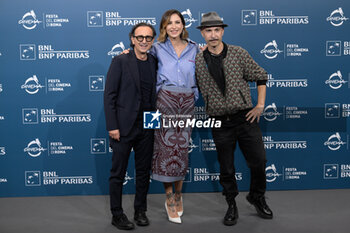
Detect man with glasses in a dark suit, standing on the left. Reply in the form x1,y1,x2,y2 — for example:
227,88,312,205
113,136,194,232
104,23,157,230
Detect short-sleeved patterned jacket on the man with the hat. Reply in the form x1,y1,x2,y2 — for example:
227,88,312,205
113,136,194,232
196,45,267,116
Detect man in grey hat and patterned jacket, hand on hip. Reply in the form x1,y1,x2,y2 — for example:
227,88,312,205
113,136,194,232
196,12,273,226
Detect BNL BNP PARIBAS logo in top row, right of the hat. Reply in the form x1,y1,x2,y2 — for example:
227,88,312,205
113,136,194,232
241,10,309,26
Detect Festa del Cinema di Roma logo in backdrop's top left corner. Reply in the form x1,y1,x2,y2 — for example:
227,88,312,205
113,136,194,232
18,10,69,30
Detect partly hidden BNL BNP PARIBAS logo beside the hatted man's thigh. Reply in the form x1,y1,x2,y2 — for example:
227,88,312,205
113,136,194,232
263,136,307,150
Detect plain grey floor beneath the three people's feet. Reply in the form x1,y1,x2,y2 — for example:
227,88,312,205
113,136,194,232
0,189,350,233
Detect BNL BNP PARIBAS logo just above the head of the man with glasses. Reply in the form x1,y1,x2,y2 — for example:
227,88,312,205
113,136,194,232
87,11,157,27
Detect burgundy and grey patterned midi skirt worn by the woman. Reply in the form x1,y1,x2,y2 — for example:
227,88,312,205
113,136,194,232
152,86,194,182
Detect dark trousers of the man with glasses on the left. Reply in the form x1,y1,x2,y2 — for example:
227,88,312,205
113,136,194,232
109,120,154,216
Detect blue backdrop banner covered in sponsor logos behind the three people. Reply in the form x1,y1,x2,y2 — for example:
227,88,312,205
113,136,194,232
0,0,350,197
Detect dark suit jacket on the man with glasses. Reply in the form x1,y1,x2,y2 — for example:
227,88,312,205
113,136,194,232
104,50,157,136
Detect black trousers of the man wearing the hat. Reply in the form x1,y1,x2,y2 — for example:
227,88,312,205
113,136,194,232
212,114,266,199
